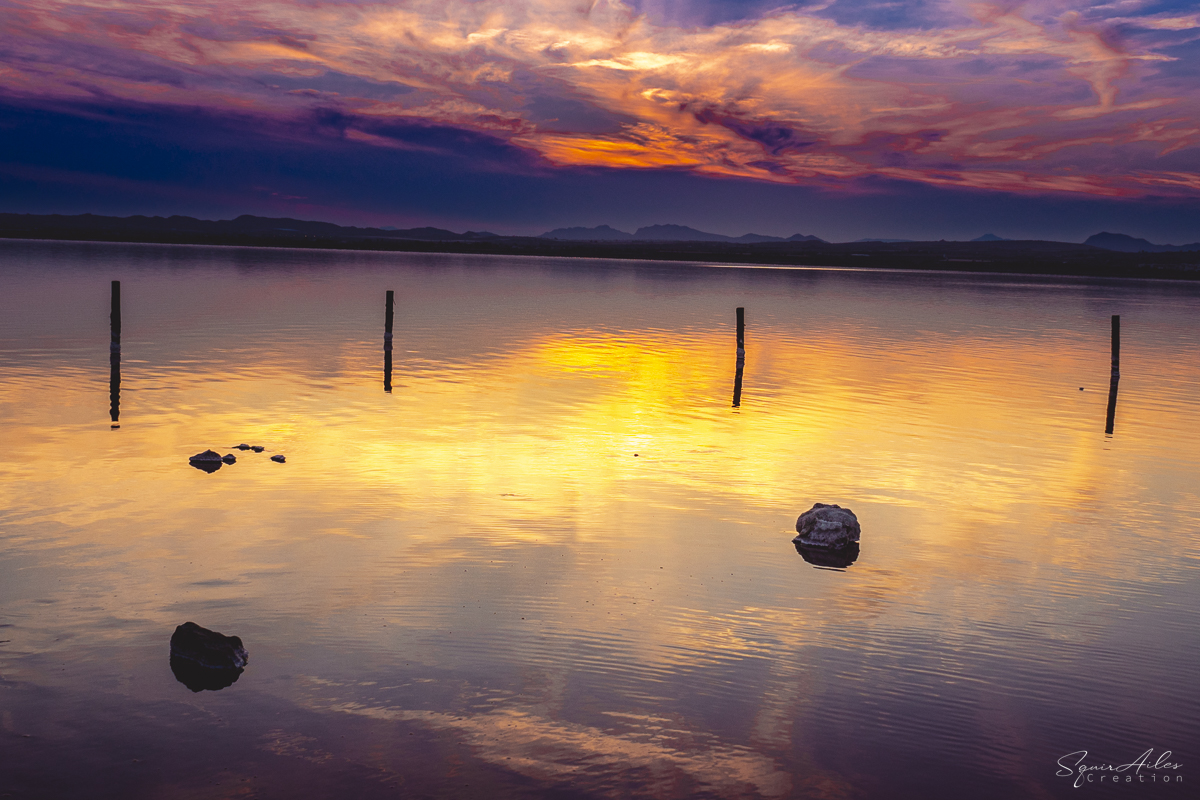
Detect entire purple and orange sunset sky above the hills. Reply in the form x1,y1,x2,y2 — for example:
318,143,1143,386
0,0,1200,243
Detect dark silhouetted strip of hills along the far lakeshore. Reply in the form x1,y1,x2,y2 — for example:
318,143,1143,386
0,213,1200,279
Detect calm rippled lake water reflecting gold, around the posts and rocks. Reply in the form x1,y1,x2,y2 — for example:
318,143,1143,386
0,241,1200,800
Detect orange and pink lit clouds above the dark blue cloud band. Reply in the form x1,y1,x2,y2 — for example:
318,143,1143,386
0,0,1200,197
